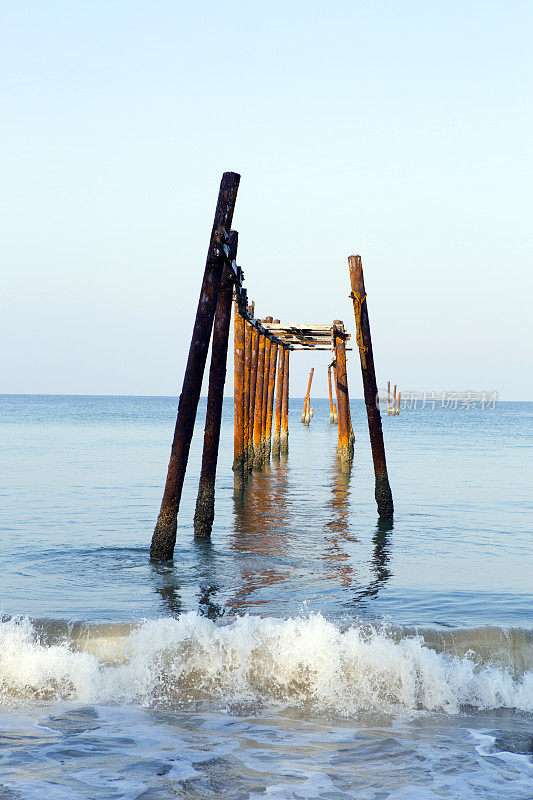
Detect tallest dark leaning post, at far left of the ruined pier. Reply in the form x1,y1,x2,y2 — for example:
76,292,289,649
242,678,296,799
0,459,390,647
150,172,240,560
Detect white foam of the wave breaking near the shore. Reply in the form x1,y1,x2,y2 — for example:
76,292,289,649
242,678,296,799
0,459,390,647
0,613,533,716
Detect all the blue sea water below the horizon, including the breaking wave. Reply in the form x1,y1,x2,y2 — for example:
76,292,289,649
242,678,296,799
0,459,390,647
0,395,533,800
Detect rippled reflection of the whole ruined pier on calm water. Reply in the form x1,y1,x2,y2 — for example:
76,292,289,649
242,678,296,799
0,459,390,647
151,444,393,619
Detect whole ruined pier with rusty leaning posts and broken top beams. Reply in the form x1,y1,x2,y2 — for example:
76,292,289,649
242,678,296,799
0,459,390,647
150,172,390,560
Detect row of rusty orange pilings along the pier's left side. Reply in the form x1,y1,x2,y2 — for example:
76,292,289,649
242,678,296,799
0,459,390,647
233,302,290,489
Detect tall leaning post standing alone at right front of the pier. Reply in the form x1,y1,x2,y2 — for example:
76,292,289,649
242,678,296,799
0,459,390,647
348,256,394,517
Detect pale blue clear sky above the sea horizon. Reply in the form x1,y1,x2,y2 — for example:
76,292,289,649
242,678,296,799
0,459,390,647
0,0,533,400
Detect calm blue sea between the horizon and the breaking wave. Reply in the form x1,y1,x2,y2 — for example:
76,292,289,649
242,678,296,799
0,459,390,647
0,397,531,627
